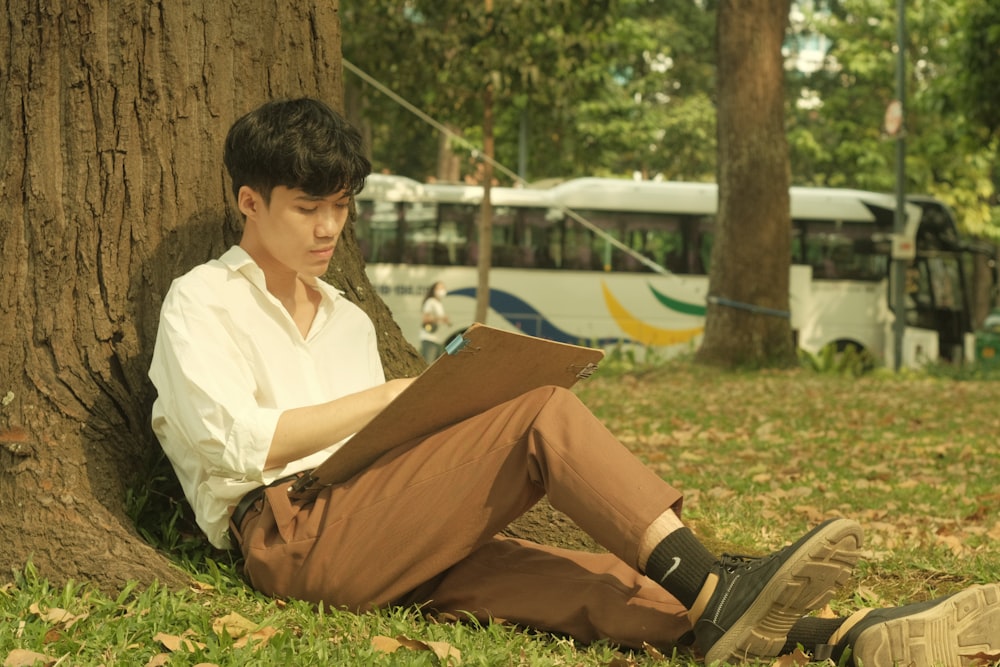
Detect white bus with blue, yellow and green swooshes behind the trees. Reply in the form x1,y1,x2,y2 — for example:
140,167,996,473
357,175,988,365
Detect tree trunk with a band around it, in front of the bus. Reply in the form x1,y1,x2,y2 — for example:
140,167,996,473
697,0,796,367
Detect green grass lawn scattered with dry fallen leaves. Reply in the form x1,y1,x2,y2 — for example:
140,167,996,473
0,362,1000,666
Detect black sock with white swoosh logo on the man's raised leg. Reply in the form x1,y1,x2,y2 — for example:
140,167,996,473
645,528,718,609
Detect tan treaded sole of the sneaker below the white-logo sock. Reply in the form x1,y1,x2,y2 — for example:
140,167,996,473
705,519,864,665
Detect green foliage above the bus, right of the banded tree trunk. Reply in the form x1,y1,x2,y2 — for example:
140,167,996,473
789,0,1000,238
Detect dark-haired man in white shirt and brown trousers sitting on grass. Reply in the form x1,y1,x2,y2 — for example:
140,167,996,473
150,99,1000,664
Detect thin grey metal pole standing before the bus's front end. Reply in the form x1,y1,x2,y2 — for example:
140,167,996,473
891,0,908,371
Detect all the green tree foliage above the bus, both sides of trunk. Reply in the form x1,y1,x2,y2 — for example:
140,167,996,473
342,0,1000,238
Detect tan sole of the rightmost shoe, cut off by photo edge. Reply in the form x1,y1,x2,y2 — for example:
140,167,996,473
851,584,1000,667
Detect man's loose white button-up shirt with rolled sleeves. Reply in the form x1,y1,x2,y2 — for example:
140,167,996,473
149,246,385,548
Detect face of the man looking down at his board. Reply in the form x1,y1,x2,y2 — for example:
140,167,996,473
240,185,351,277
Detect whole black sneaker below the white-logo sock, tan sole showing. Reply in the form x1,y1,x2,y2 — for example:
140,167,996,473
693,519,861,665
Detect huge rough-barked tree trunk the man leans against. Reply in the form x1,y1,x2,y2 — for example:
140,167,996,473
0,0,420,589
